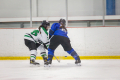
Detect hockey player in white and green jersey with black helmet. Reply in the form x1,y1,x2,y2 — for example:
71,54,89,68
24,20,50,65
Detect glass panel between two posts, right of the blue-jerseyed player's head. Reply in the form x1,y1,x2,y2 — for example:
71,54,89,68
68,0,103,27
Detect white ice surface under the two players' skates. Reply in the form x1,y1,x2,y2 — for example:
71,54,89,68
0,59,120,80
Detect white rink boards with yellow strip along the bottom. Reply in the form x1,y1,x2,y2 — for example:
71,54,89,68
0,27,120,60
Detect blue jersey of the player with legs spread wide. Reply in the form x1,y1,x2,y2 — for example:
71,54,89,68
49,23,68,38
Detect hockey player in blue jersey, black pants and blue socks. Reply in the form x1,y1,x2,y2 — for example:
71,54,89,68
48,19,81,65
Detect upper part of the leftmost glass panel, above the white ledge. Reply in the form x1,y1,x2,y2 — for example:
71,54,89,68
0,0,30,18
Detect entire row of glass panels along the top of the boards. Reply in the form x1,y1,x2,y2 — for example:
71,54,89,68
0,0,120,28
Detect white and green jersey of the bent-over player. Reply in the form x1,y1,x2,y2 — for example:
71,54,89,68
24,27,49,46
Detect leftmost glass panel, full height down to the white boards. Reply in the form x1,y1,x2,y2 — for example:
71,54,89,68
0,0,30,28
